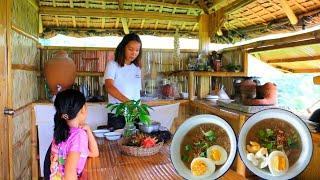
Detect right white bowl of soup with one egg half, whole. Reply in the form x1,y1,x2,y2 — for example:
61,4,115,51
238,109,313,180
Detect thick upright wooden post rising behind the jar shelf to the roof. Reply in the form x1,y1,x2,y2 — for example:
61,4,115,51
197,14,210,99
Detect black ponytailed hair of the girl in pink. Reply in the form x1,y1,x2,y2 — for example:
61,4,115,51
53,89,86,144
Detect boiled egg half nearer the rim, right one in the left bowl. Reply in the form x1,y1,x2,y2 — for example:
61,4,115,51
207,145,228,165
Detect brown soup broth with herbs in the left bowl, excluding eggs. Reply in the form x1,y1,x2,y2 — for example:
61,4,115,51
180,123,230,169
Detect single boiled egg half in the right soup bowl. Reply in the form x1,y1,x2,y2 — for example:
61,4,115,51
268,151,289,176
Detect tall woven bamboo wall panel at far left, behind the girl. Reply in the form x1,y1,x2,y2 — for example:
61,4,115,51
8,0,40,179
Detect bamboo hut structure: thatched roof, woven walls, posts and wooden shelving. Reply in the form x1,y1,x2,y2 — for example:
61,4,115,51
0,0,320,179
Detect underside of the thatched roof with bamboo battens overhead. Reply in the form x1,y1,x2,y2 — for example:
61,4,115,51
39,0,320,43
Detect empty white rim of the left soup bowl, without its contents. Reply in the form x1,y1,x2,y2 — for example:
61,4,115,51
170,114,237,179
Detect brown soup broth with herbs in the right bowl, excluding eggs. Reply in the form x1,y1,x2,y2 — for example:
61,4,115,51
246,118,302,166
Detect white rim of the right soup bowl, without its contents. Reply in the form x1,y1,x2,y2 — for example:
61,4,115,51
238,109,313,180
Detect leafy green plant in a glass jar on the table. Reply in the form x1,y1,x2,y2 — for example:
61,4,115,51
106,100,152,137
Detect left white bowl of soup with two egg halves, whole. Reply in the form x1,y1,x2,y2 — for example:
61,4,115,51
170,114,237,179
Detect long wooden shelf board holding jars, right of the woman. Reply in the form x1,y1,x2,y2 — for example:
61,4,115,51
160,71,247,77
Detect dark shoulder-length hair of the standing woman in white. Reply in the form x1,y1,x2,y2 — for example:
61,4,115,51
115,33,142,67
